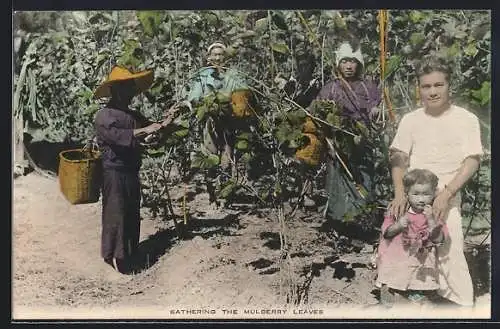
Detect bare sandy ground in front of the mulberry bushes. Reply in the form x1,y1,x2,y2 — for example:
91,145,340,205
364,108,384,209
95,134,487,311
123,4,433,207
12,173,489,318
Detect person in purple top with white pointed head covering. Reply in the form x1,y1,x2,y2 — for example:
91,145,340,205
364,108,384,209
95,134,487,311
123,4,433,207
316,43,382,228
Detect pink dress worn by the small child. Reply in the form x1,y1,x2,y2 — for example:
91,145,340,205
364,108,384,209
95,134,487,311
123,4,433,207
376,209,448,290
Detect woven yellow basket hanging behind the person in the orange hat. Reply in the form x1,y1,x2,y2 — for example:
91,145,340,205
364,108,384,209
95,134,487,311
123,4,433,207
59,148,102,204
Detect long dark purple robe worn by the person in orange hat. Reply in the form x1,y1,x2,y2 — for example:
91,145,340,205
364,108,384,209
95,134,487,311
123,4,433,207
95,107,147,261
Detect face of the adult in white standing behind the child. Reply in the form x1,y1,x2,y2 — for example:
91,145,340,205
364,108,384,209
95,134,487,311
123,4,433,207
419,71,450,111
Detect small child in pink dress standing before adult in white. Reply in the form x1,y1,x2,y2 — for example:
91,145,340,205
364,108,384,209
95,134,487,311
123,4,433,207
376,169,448,304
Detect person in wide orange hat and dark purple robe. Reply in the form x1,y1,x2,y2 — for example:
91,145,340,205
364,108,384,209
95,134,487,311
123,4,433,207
95,67,177,273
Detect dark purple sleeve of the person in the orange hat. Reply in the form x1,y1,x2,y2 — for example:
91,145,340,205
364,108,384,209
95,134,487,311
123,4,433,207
94,111,136,147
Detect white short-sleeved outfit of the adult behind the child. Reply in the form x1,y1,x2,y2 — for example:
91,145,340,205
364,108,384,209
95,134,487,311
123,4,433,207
391,105,483,306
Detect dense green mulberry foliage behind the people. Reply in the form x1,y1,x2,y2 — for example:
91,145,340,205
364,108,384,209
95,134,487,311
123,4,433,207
13,10,491,236
